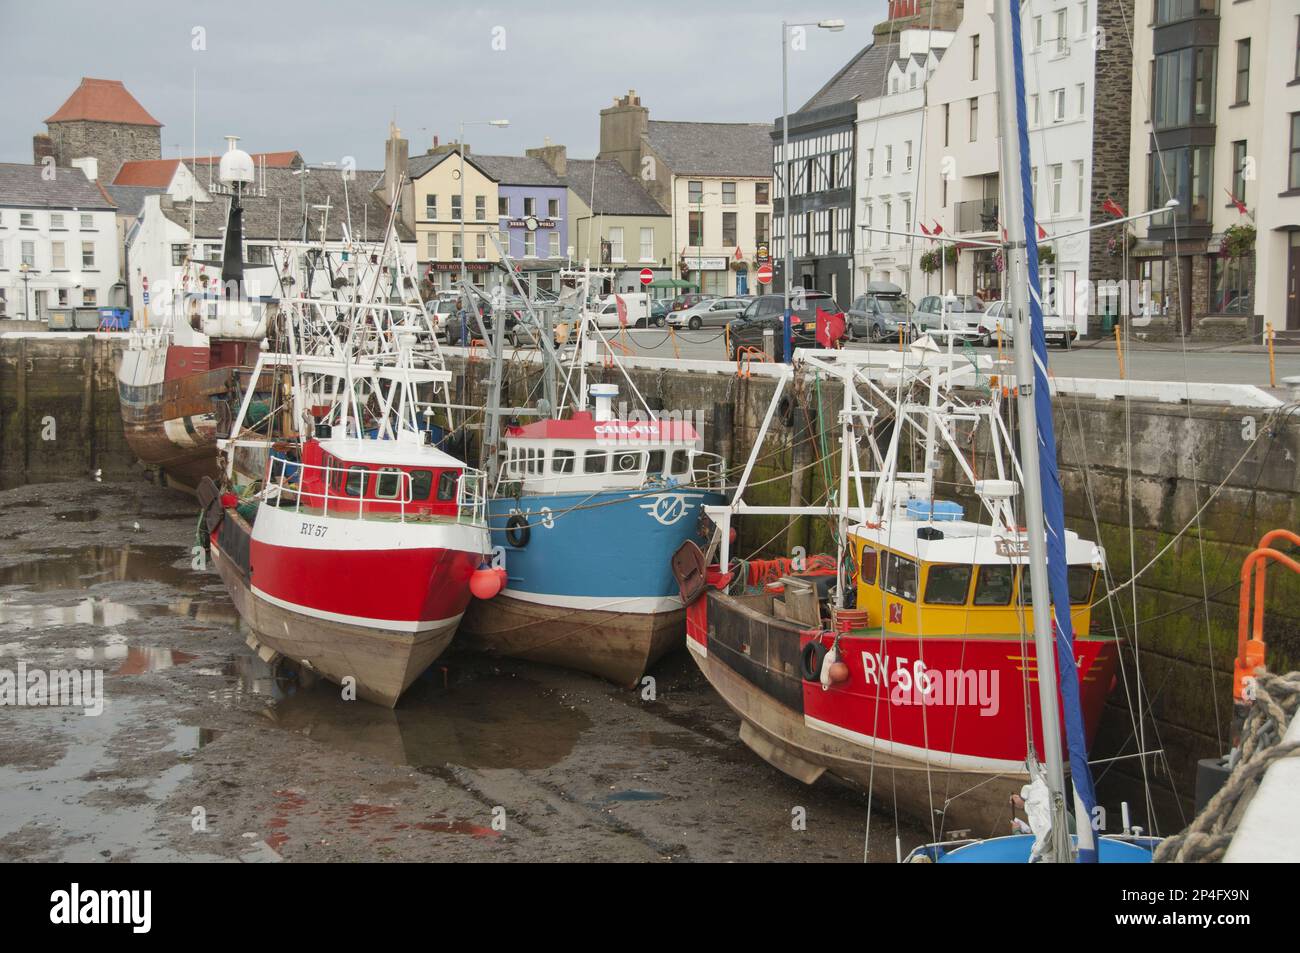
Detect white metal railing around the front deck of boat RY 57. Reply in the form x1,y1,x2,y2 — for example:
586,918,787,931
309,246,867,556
263,451,488,523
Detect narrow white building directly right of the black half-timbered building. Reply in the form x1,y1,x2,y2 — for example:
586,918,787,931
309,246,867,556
854,30,953,300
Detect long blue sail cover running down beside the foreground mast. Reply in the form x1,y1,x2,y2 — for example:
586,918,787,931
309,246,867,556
1002,0,1097,863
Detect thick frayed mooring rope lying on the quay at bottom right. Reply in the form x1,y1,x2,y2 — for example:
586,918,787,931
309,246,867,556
1156,671,1300,863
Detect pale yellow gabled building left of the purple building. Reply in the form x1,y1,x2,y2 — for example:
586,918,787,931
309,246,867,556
408,144,501,291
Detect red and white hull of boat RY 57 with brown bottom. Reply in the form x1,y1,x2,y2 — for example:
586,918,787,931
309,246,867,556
211,506,486,707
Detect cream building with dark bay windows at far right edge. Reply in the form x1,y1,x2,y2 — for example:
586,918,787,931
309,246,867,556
1130,0,1300,339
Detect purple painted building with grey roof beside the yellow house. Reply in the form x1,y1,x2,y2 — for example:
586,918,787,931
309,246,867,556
473,155,569,291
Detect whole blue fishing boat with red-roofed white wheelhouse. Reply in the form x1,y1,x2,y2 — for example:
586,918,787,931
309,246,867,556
452,260,725,685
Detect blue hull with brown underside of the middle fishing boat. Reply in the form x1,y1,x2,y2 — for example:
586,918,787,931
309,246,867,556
462,490,724,685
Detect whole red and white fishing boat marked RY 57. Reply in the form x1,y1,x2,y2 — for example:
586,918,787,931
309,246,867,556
199,213,497,707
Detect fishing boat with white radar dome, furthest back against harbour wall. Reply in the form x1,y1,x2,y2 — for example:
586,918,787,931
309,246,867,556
117,137,278,491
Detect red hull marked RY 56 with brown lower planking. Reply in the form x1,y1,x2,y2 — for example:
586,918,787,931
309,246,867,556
686,592,1115,837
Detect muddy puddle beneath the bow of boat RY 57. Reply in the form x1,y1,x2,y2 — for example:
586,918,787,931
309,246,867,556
224,654,592,771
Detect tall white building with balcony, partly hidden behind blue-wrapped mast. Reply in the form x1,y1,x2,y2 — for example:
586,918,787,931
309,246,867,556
909,0,1112,334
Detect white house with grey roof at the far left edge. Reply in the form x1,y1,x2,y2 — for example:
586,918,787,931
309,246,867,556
0,160,126,321
